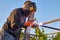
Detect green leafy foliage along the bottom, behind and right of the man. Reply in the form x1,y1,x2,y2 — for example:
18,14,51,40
20,28,60,40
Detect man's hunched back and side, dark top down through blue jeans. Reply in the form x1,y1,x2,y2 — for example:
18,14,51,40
2,8,26,40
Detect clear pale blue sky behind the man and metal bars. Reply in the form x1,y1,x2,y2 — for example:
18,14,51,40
0,0,60,33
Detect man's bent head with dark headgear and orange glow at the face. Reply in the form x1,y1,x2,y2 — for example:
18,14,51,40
23,1,36,12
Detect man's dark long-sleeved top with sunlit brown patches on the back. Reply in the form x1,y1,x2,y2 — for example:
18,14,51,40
3,8,26,37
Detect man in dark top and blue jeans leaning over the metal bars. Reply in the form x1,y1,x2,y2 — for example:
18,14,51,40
2,1,36,40
